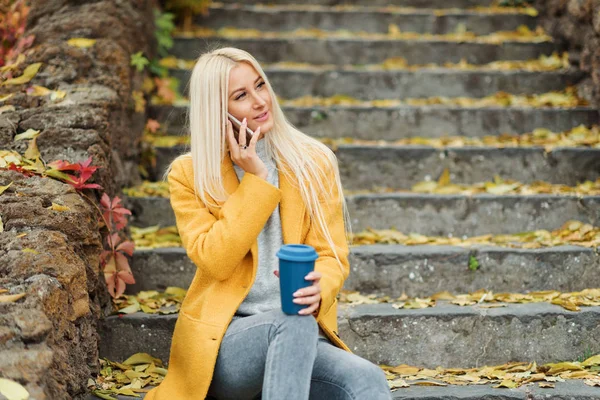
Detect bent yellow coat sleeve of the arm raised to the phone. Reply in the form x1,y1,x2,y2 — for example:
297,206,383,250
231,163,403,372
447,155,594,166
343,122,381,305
168,162,281,281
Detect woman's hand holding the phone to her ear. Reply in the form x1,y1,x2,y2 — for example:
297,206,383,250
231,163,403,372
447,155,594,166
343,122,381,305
227,118,268,180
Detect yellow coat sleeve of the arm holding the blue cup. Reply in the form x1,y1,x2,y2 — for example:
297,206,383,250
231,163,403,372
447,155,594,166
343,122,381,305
305,159,350,319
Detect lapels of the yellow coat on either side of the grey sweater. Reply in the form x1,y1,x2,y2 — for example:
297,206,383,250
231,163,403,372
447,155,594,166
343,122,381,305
221,154,306,247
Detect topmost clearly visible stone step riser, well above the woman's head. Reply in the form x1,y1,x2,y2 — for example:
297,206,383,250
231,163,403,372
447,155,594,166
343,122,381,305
194,4,536,35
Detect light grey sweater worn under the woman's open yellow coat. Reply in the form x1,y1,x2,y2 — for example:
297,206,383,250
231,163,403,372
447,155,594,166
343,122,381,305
233,139,326,337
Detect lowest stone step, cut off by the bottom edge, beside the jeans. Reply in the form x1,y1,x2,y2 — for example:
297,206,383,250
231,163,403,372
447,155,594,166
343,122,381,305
88,380,600,400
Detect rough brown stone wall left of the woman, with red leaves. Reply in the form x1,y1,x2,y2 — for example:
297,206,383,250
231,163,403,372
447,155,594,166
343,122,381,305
0,0,155,400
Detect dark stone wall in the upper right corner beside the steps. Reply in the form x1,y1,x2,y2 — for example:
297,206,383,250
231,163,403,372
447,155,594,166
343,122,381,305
534,0,600,106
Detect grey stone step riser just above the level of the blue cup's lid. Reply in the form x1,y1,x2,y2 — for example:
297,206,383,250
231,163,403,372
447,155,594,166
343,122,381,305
126,193,600,236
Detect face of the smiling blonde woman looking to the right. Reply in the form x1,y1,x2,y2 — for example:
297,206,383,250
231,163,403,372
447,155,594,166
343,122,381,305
227,62,273,134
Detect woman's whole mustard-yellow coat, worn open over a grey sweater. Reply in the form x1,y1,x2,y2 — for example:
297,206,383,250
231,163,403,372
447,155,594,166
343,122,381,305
146,155,350,400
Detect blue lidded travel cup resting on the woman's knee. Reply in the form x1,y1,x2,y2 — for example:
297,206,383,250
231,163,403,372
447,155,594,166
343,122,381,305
277,244,319,315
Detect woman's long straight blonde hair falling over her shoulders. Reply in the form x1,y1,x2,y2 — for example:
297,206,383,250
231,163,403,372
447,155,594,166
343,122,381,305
163,47,352,268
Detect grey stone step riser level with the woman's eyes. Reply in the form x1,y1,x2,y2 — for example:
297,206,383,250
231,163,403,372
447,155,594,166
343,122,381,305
170,67,583,100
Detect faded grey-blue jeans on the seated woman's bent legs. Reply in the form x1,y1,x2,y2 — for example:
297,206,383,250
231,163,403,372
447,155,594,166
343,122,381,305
208,310,392,400
